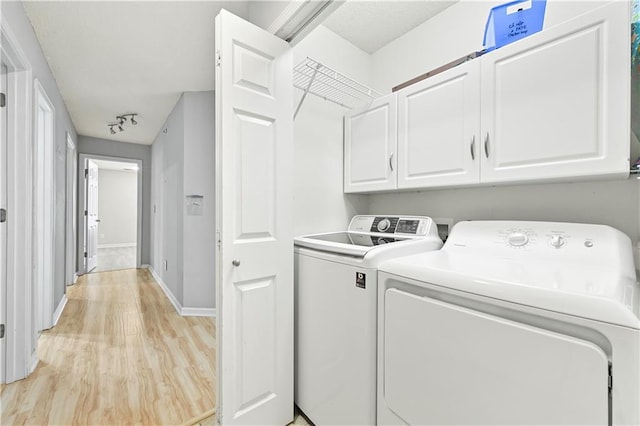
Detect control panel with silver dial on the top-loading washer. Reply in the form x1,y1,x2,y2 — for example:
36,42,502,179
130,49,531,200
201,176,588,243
349,215,436,236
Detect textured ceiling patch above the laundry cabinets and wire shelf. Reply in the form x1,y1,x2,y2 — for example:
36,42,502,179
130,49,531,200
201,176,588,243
324,0,458,53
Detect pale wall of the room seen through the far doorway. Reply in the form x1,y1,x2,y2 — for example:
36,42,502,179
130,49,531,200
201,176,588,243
98,169,138,247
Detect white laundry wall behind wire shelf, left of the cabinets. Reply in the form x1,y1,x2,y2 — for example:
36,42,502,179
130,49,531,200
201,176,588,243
294,25,372,235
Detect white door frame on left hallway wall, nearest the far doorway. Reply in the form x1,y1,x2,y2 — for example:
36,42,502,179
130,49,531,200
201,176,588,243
65,132,78,285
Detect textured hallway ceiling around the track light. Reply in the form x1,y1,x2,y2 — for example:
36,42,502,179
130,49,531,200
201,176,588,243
24,1,249,144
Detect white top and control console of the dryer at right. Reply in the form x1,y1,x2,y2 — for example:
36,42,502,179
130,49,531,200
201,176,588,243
380,221,640,329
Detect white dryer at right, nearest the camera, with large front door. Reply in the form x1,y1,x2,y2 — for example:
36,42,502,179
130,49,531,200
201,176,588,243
378,221,640,425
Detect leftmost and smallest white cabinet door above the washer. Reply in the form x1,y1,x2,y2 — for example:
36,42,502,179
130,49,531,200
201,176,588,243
344,93,398,192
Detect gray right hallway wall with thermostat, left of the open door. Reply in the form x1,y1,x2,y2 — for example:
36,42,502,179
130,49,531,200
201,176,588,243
151,92,215,309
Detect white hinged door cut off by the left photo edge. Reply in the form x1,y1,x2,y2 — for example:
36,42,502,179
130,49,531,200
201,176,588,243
0,60,8,383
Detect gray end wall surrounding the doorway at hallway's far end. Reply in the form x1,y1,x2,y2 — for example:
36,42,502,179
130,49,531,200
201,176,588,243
78,136,151,262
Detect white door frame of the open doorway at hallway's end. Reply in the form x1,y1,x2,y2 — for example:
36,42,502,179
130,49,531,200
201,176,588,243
76,153,142,275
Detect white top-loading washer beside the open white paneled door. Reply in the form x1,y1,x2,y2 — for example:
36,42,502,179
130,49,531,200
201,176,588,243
295,216,442,425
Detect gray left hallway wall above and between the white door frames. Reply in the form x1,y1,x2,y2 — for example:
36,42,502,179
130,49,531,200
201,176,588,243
2,1,77,316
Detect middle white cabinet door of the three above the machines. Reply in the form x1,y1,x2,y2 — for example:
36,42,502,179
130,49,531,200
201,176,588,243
398,60,480,188
